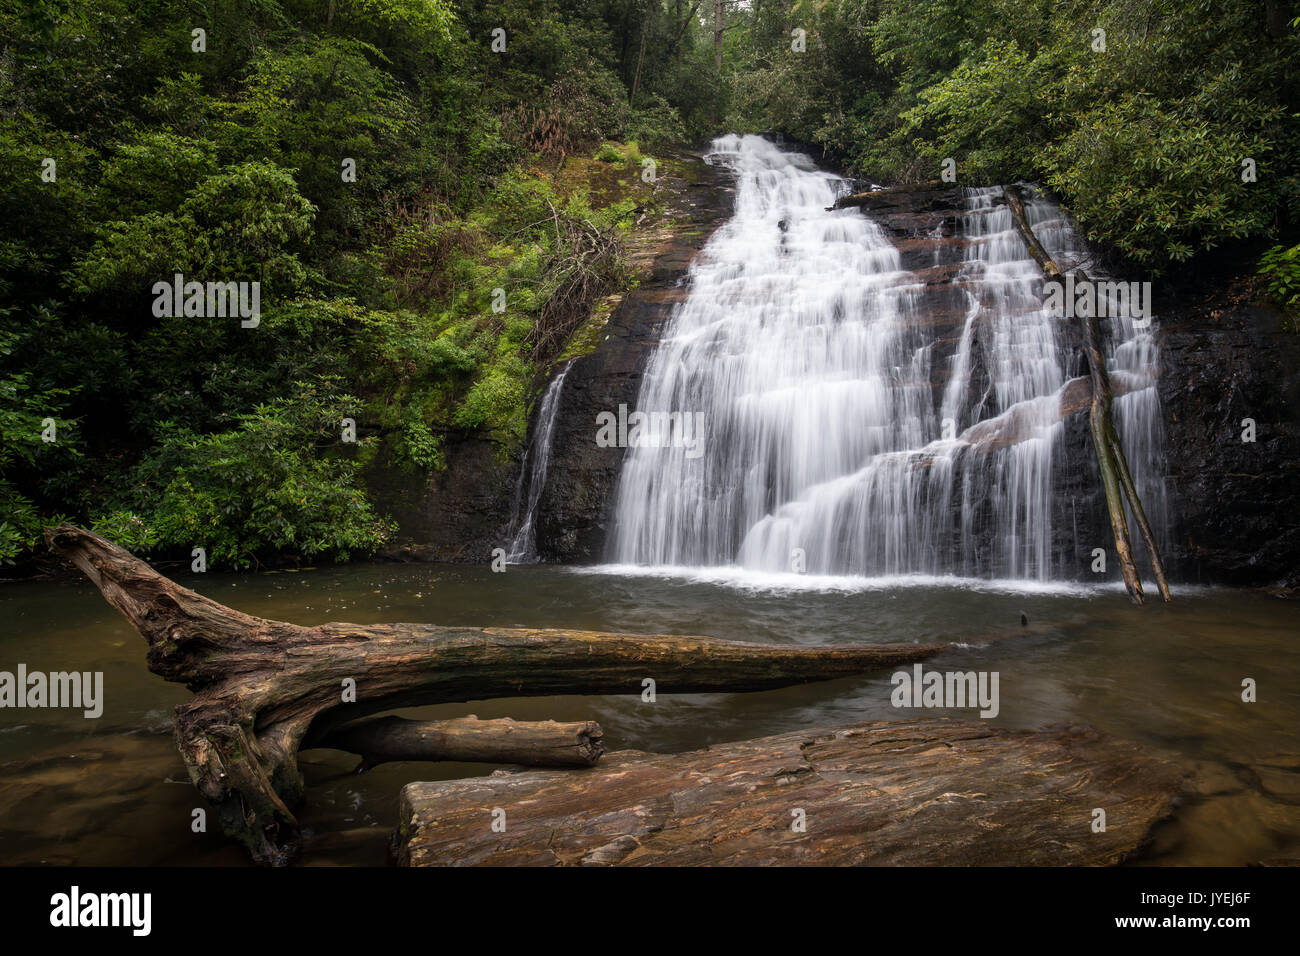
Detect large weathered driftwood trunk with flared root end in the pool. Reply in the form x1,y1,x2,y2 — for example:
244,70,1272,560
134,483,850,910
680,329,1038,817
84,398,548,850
46,524,954,864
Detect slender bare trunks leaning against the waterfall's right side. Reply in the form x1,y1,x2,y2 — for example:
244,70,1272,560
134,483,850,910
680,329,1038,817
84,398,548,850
1002,186,1170,604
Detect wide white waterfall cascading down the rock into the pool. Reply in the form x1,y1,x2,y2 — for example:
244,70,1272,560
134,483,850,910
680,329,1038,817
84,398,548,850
610,137,1164,580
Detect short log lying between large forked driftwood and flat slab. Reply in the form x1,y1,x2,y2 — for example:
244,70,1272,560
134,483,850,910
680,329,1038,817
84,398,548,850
313,715,605,773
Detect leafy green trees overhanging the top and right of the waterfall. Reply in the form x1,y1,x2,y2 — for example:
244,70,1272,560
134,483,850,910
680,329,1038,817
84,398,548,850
724,0,1300,274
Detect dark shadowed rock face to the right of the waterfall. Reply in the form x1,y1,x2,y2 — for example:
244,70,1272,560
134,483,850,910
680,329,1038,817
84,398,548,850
1160,291,1300,588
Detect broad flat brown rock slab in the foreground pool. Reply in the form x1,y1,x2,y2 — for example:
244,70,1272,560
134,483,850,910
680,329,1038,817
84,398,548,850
394,718,1186,866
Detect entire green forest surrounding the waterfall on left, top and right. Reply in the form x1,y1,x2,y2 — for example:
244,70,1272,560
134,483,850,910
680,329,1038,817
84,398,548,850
0,0,1300,574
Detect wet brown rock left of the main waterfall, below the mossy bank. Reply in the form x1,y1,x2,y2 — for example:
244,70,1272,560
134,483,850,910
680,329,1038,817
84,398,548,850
367,145,731,563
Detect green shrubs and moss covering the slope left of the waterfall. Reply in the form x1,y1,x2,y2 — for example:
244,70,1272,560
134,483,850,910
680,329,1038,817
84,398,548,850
0,0,685,566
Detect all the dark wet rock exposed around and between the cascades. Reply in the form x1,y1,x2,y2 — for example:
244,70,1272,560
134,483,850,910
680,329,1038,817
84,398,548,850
374,157,1300,587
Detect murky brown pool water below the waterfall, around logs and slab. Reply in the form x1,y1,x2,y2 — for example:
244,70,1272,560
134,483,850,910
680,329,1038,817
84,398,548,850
0,564,1300,865
